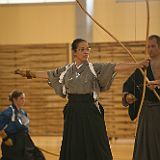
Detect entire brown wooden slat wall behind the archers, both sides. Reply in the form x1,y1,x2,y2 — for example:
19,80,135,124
0,41,144,138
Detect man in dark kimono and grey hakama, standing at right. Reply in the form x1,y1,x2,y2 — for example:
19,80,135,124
122,35,160,160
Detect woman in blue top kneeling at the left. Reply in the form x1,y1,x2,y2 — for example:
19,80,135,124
0,89,45,160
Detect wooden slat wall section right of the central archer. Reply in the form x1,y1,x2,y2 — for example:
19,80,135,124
90,41,145,138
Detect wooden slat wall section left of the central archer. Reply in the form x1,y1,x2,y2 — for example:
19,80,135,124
0,44,68,135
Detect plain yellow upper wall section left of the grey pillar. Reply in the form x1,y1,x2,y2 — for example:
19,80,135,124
0,3,75,44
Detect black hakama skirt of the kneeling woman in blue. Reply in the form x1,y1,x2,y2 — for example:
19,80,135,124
1,131,45,160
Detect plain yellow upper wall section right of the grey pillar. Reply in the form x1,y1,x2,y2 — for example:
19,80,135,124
93,0,160,42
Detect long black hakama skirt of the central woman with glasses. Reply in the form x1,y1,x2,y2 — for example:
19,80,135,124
60,94,112,160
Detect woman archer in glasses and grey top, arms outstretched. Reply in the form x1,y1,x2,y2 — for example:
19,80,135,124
16,39,149,160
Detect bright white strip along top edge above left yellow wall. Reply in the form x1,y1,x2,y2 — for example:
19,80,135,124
0,0,75,4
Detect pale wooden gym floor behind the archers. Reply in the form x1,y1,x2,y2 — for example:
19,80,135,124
32,137,134,160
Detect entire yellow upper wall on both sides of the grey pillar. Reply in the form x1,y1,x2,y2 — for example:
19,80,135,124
0,0,160,44
